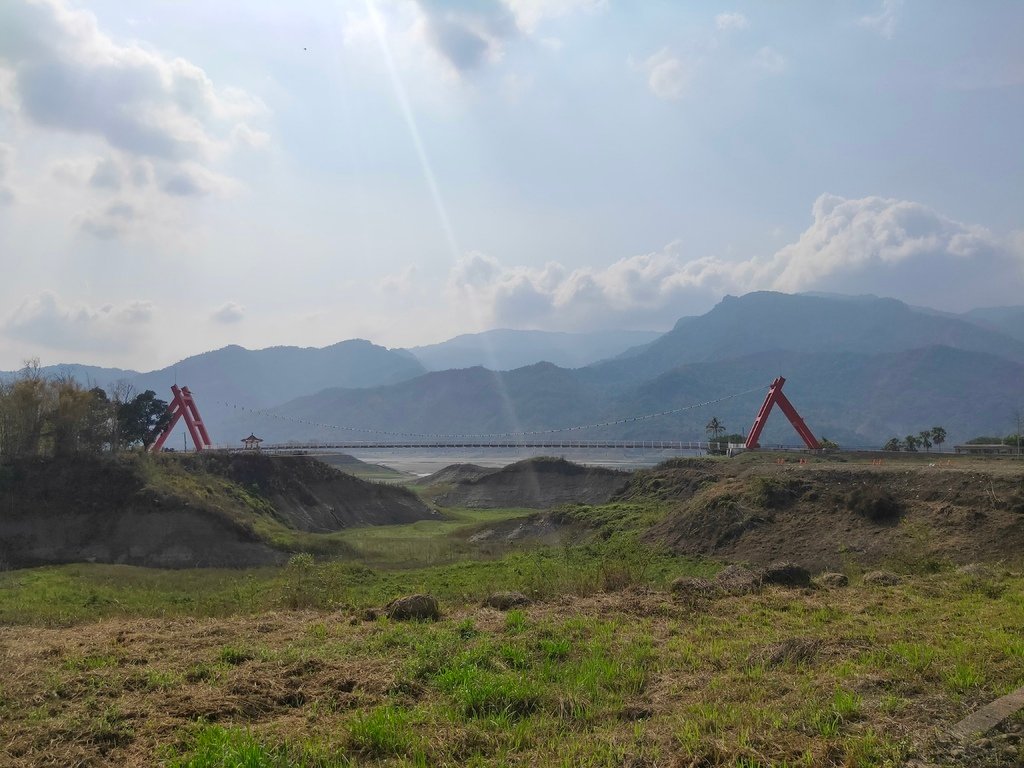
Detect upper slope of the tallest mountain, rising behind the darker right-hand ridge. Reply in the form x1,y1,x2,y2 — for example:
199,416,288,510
589,292,1024,386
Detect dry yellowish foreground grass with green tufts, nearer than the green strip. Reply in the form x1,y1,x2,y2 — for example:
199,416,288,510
0,558,1024,767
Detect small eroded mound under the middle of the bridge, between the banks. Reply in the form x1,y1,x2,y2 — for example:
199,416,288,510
437,458,630,509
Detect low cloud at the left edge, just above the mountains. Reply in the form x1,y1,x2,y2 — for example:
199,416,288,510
3,291,155,352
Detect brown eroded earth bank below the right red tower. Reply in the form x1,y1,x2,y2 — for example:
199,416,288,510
638,459,1024,569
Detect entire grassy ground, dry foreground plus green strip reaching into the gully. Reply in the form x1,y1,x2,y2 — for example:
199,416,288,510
0,456,1024,768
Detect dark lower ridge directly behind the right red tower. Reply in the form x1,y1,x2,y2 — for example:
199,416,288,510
598,346,1024,446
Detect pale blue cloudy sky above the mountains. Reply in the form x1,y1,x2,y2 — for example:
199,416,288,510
0,0,1024,370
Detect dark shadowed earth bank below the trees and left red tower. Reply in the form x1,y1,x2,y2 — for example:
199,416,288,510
0,455,435,567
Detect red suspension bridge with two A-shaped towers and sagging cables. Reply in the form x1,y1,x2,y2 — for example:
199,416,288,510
151,377,821,453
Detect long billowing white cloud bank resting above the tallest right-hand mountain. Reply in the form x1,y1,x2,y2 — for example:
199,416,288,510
449,195,1024,330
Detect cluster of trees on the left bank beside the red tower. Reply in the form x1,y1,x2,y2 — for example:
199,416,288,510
0,361,170,460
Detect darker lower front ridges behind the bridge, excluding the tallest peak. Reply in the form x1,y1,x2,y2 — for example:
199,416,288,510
232,346,1024,446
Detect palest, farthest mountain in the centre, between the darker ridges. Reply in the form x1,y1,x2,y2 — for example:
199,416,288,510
409,329,662,371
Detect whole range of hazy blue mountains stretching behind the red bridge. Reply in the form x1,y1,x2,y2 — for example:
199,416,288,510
0,292,1024,446
